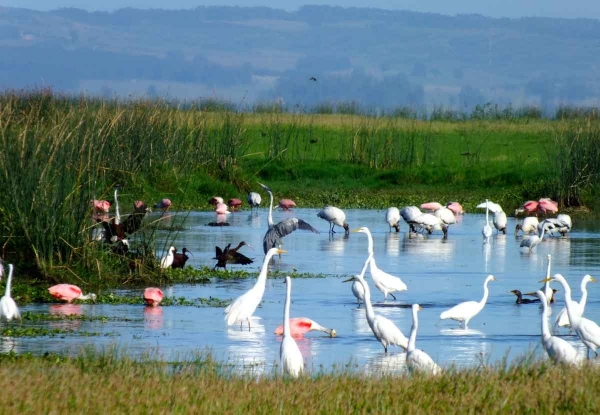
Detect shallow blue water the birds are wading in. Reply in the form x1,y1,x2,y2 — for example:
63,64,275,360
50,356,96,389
10,209,600,373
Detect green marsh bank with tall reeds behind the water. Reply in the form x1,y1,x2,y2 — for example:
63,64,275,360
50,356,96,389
0,91,600,284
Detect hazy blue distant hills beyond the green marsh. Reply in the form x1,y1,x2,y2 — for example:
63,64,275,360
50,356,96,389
0,6,600,110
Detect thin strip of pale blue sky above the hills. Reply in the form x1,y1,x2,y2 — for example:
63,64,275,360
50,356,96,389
0,0,600,19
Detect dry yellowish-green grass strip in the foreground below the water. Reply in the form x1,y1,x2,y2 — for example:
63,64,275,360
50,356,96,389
0,352,600,413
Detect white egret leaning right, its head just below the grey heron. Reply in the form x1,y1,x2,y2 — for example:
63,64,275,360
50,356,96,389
224,248,287,331
